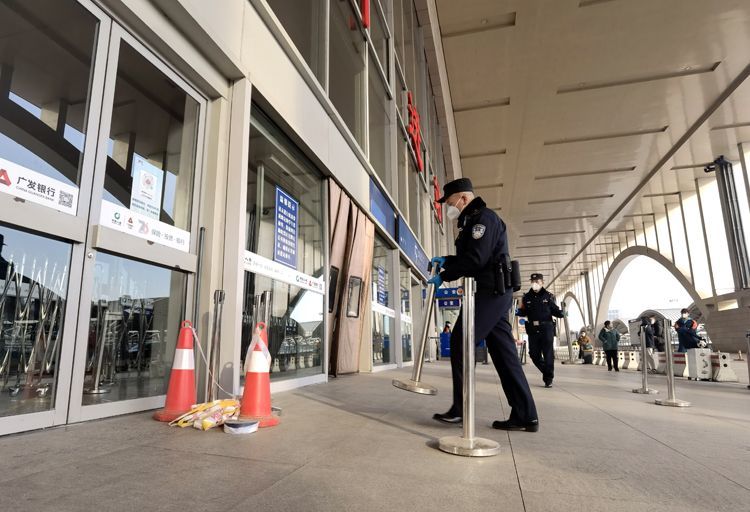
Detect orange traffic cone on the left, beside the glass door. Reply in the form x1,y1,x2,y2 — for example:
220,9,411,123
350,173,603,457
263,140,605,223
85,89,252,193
154,320,195,421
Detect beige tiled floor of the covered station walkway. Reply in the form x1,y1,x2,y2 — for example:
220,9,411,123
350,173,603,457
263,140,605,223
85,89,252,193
0,362,750,512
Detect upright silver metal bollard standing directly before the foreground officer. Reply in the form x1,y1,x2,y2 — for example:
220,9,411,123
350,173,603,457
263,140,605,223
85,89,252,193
439,277,500,457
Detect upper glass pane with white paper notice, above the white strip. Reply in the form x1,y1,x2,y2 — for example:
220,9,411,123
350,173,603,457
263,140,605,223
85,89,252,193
104,41,203,231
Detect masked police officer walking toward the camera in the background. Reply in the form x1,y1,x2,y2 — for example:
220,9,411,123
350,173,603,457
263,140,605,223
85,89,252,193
518,274,565,388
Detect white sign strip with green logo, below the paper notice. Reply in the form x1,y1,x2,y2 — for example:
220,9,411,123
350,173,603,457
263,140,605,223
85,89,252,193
99,201,190,252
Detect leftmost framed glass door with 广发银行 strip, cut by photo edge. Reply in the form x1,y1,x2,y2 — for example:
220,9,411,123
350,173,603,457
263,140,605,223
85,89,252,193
0,0,111,435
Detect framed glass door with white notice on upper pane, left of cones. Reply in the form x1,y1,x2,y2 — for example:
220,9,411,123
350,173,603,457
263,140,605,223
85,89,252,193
70,24,206,421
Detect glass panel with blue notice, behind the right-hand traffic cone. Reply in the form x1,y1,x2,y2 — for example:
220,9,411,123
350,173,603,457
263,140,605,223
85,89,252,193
240,108,325,380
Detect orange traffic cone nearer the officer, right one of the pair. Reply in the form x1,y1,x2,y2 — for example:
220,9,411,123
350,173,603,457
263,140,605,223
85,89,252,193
240,322,279,427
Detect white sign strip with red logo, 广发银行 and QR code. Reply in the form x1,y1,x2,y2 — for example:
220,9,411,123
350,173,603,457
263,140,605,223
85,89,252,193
0,158,78,215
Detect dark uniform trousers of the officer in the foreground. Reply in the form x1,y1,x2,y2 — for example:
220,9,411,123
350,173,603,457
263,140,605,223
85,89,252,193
451,291,538,423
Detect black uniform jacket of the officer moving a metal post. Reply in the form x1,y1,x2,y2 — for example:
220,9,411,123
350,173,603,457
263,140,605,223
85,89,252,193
440,197,508,291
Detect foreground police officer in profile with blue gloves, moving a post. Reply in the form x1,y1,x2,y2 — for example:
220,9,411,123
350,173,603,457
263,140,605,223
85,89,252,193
429,178,539,432
